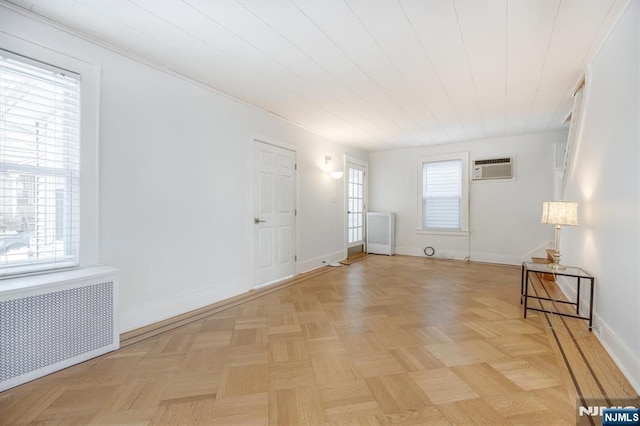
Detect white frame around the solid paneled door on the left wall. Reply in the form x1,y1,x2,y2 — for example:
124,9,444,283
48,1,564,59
246,133,300,290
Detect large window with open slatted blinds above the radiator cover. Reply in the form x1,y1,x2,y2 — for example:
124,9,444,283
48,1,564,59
0,51,80,276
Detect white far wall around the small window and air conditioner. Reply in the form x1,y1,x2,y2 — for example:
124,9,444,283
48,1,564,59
369,131,567,264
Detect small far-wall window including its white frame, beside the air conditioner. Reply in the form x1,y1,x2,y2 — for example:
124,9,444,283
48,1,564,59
418,153,469,233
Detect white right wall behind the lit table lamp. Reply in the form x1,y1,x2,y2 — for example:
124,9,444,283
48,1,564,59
562,1,640,392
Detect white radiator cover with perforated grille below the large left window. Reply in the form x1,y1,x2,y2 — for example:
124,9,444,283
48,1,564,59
0,266,120,392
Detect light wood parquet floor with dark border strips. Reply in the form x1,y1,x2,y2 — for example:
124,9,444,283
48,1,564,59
0,256,636,425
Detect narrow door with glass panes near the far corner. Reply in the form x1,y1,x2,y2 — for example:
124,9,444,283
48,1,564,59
347,162,366,247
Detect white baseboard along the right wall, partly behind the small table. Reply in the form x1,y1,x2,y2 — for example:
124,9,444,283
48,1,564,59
556,277,640,394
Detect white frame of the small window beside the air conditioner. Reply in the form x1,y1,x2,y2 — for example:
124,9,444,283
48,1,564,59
416,152,469,236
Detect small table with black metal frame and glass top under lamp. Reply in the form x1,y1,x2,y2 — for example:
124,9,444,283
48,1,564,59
520,262,595,331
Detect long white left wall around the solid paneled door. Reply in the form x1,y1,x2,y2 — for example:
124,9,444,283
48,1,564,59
0,6,367,331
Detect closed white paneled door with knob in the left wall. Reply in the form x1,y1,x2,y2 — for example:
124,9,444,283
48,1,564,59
253,141,296,286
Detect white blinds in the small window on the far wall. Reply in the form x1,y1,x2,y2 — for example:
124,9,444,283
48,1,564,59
422,160,462,229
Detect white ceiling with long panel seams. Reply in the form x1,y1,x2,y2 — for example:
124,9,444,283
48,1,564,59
5,0,628,150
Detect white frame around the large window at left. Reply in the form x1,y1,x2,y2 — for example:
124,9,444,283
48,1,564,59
0,34,100,278
